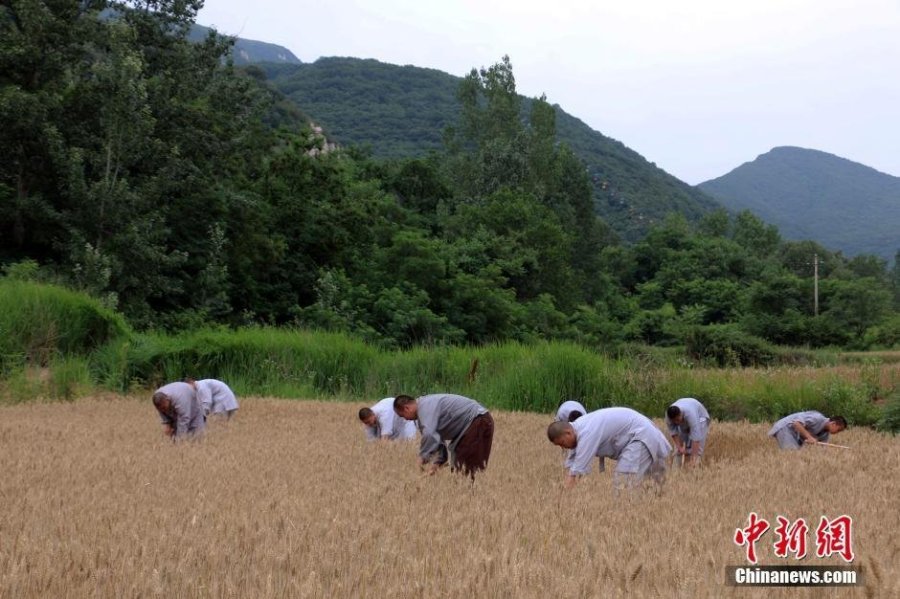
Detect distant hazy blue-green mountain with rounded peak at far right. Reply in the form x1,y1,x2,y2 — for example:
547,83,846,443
699,147,900,260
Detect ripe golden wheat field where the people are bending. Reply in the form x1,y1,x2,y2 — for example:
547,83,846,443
0,396,900,598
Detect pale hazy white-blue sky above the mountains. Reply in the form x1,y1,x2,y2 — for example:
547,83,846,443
198,0,900,184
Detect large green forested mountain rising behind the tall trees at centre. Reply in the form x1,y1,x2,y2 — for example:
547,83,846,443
263,58,718,241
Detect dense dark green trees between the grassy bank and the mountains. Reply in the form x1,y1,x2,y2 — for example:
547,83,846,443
0,0,900,363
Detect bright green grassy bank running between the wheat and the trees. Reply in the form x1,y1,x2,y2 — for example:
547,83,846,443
0,282,900,424
